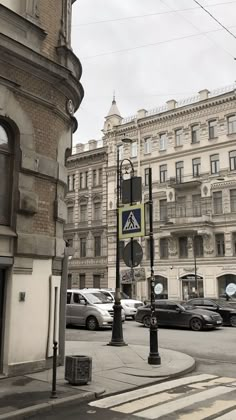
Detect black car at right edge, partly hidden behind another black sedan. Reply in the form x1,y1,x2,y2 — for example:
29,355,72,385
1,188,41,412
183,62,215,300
184,298,236,327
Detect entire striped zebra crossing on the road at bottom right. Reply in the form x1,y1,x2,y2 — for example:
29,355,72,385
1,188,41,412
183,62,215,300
89,374,236,420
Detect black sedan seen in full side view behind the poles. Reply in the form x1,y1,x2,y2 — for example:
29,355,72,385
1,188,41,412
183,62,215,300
135,300,222,331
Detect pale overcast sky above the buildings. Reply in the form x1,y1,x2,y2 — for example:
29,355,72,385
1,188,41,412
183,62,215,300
72,0,236,144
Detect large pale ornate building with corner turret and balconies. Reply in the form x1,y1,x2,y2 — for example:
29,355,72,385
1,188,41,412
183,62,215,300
103,85,236,300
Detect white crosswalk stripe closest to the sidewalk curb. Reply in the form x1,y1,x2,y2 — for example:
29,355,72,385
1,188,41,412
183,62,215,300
89,374,217,408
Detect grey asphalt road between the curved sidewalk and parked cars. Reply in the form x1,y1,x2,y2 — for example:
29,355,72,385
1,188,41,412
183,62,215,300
66,320,236,378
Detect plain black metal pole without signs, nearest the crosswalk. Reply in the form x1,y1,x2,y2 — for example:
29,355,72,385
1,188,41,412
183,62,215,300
148,168,161,365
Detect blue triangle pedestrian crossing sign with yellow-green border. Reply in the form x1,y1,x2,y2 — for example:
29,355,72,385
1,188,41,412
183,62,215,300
119,204,145,239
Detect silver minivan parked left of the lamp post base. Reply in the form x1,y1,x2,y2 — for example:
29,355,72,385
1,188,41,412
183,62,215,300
66,289,125,331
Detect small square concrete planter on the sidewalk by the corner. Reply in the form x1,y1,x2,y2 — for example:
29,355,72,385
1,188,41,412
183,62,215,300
65,355,92,385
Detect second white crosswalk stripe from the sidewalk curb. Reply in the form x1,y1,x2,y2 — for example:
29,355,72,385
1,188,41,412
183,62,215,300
135,386,232,420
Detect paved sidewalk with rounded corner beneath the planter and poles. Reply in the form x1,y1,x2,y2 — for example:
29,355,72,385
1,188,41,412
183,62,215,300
0,341,195,420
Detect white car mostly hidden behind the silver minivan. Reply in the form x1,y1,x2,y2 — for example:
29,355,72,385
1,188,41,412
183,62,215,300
85,288,144,319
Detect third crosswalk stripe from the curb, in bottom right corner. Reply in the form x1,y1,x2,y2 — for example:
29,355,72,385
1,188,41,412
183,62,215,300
177,400,236,420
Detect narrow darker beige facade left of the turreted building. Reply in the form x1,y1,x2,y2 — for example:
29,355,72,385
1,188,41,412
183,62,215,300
65,140,108,289
